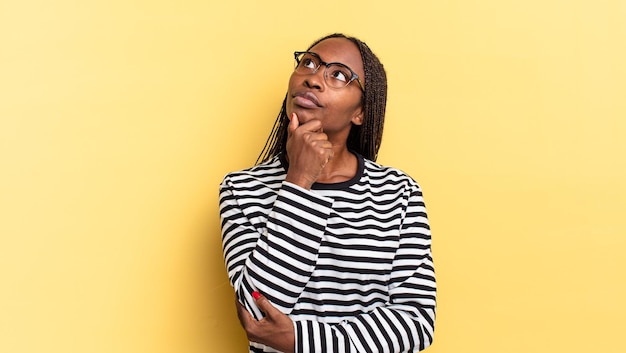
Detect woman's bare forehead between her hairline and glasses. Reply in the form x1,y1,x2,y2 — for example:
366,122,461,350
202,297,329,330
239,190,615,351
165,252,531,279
310,38,364,77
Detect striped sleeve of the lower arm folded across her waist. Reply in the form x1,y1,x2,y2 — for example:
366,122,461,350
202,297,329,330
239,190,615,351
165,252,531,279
294,189,436,353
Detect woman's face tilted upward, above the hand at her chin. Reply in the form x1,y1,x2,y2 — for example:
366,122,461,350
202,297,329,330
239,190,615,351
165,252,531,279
286,38,365,142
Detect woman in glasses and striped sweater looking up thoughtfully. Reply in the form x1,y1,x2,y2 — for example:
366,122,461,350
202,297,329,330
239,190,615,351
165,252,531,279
220,34,435,352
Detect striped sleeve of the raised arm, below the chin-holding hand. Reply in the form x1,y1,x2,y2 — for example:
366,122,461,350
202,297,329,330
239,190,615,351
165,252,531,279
220,177,332,319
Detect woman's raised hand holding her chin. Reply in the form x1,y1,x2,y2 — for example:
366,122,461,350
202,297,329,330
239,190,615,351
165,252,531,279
285,113,333,189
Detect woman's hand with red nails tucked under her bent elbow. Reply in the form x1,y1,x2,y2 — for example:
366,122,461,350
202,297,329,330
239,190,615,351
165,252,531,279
235,293,295,353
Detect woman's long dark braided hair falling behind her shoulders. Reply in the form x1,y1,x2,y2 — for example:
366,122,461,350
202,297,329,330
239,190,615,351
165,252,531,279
257,33,387,163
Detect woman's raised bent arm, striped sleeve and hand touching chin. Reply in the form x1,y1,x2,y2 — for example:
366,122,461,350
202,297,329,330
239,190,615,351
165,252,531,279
220,113,333,319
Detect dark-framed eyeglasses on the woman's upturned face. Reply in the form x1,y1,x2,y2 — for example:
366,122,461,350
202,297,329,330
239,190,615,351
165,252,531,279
293,51,365,92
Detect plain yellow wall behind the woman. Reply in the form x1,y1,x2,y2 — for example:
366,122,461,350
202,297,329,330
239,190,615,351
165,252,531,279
0,0,626,353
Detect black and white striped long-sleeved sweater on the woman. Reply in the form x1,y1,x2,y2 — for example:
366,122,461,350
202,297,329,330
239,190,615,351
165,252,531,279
219,156,436,352
